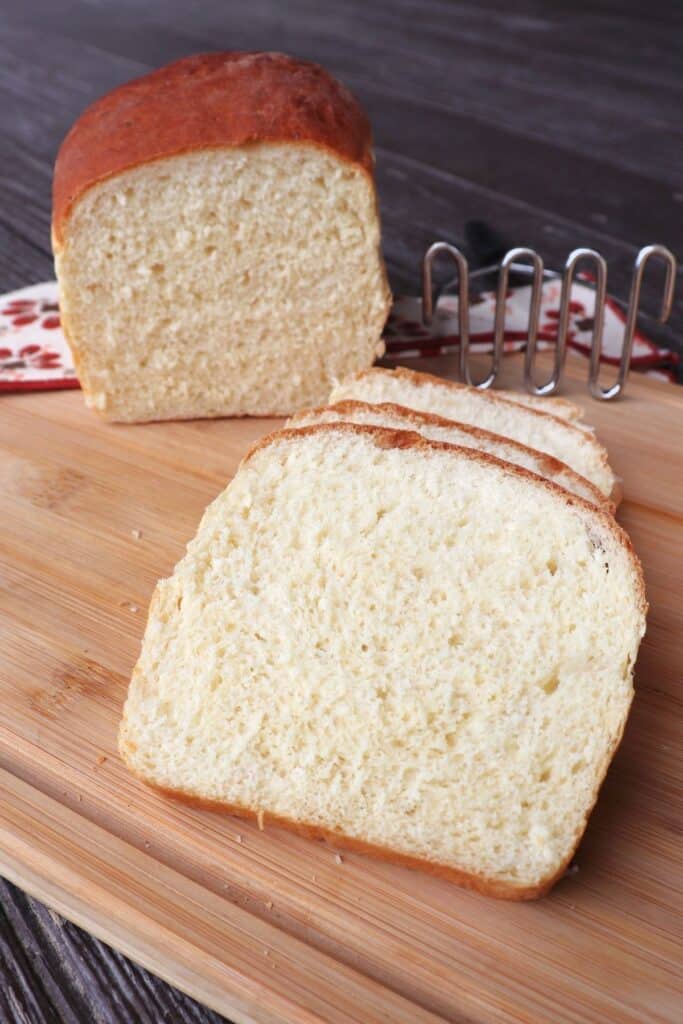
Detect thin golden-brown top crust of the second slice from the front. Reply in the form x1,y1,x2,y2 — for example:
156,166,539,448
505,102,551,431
289,398,615,515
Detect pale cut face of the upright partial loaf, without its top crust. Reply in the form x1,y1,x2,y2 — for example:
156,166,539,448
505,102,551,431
54,142,389,422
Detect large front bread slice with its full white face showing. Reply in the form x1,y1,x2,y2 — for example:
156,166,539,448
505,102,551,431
120,423,645,899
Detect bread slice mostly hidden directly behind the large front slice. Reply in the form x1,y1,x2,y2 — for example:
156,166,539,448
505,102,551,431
288,399,614,515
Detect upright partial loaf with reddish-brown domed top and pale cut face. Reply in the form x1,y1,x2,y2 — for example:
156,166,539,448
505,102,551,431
52,52,389,421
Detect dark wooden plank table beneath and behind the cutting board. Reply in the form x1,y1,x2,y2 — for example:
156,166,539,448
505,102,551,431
0,0,683,1024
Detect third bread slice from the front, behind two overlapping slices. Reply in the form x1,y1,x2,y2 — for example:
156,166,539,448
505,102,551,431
329,367,616,498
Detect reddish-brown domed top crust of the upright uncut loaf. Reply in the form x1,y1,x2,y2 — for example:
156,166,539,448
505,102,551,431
52,51,373,243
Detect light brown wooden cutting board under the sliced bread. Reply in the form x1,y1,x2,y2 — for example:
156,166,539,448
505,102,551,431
0,360,683,1024
